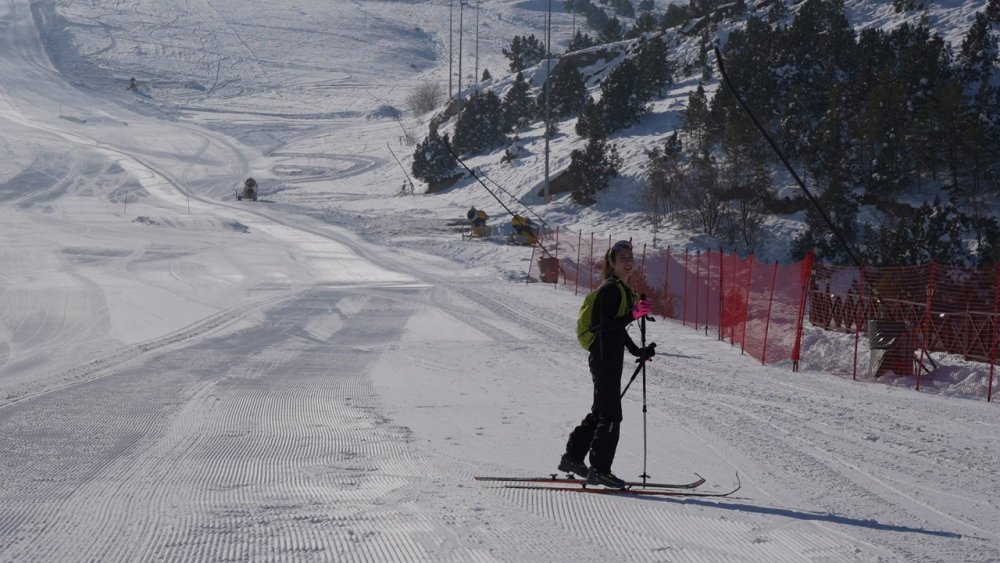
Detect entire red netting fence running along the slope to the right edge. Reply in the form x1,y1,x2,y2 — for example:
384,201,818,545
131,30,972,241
528,229,1000,400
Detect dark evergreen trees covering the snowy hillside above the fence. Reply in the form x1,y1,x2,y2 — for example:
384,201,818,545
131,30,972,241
413,0,1000,266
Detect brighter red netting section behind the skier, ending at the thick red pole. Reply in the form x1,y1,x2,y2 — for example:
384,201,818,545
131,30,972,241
529,231,812,368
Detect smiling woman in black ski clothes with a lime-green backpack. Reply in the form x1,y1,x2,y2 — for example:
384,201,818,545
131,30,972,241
559,240,656,489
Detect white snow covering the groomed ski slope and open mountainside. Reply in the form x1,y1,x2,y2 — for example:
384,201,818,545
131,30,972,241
0,0,1000,562
